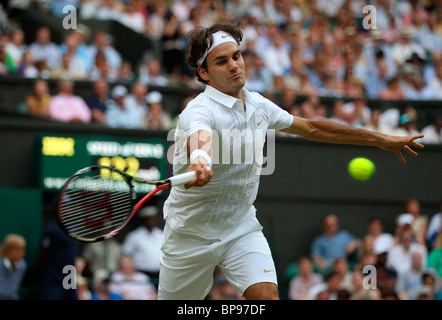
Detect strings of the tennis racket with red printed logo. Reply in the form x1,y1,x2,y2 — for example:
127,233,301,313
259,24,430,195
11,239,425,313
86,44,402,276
59,170,132,239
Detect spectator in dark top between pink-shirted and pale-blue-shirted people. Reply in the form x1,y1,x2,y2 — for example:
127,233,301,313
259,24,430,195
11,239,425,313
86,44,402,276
86,78,109,124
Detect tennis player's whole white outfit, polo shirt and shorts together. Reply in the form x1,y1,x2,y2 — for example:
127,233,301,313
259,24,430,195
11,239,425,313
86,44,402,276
158,86,293,300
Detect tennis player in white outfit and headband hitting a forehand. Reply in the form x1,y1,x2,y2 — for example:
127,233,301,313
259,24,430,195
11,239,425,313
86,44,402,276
158,23,423,300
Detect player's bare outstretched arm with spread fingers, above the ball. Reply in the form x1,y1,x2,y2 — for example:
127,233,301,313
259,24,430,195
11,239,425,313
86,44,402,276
281,117,424,163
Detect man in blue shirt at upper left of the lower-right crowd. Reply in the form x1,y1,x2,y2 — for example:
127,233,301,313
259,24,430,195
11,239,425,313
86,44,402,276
310,214,359,270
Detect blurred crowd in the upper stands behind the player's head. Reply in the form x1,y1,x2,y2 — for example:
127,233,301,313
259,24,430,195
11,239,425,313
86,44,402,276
0,0,442,143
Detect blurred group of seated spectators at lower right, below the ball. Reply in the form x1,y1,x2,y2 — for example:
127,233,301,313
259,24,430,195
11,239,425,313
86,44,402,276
285,198,442,300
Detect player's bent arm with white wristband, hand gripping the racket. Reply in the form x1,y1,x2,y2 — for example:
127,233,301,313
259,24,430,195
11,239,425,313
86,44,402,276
184,130,213,188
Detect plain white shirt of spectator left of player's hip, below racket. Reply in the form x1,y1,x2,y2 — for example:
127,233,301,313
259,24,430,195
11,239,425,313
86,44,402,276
122,226,163,272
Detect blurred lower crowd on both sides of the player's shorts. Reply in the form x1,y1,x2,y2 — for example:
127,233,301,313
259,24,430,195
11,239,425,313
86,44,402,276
0,198,442,300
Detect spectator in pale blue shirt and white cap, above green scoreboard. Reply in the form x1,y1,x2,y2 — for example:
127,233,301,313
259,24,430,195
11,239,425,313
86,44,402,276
106,85,145,129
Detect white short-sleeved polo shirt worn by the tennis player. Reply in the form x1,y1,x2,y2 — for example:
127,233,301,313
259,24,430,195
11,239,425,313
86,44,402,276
163,85,293,239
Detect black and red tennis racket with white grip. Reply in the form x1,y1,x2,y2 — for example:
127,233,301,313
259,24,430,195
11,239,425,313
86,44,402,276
57,165,196,242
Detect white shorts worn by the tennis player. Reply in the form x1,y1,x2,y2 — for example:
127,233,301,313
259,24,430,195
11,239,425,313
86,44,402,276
158,219,277,300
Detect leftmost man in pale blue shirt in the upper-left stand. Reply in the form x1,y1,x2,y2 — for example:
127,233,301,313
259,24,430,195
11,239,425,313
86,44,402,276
29,27,61,69
